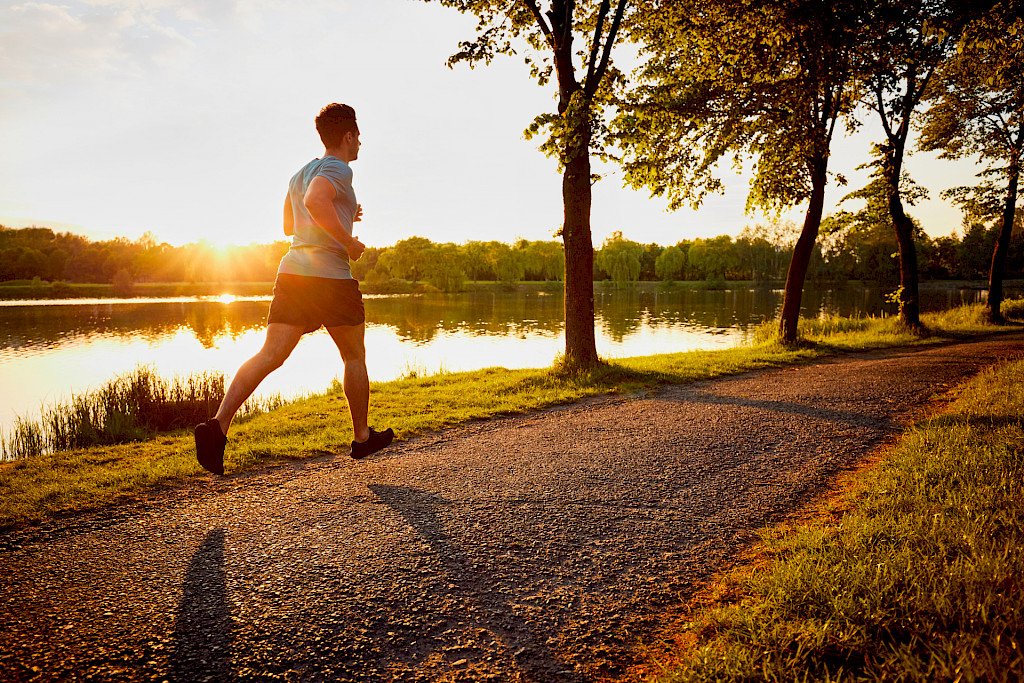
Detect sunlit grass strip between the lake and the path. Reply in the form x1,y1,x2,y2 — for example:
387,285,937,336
0,301,1024,525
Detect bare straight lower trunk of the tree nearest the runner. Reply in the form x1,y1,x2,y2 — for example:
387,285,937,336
562,122,597,368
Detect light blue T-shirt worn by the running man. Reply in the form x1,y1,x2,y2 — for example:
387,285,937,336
278,157,357,280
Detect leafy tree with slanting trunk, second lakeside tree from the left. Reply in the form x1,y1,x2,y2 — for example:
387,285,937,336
616,0,866,342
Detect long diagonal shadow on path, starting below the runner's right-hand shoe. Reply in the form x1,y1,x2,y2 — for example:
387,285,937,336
368,484,579,681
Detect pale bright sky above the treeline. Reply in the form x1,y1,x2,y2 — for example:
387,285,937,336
0,0,980,247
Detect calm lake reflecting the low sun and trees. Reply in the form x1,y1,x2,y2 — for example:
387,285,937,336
0,284,1007,431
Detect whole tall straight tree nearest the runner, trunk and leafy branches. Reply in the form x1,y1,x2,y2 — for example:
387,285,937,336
426,0,627,367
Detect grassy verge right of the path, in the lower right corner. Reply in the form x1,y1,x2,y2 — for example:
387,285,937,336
630,350,1024,683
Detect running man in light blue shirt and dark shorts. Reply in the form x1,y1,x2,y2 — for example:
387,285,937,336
196,103,394,474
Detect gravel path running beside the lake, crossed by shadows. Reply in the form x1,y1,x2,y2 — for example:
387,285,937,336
6,334,1024,683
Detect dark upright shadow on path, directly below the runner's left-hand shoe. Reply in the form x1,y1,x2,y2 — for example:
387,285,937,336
171,528,234,681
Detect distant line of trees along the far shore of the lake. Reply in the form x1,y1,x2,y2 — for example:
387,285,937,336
0,211,1024,293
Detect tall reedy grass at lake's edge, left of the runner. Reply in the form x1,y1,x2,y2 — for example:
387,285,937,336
0,366,283,460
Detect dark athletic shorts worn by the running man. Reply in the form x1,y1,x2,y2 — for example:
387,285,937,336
266,272,366,334
